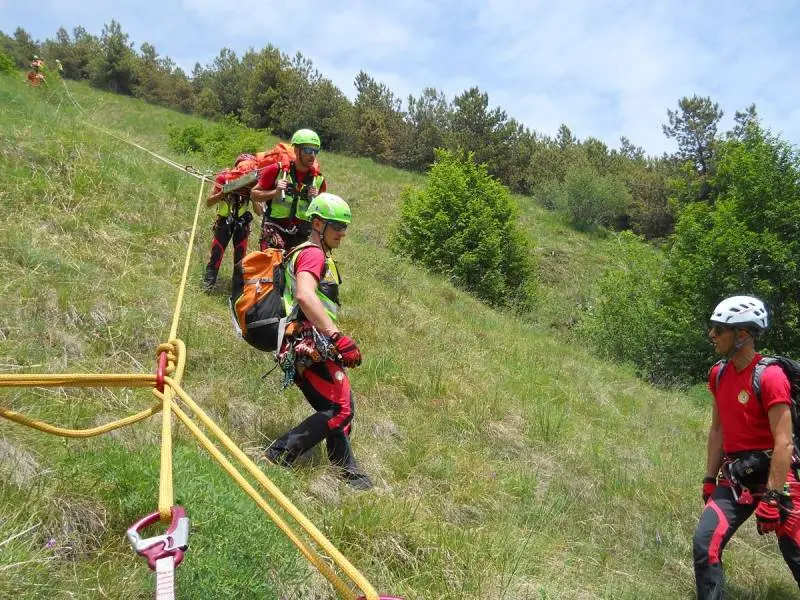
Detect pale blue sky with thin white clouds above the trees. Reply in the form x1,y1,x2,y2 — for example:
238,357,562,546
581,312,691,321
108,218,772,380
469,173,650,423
0,0,800,154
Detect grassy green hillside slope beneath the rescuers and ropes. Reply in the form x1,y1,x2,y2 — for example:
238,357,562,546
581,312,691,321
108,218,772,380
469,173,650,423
0,77,796,600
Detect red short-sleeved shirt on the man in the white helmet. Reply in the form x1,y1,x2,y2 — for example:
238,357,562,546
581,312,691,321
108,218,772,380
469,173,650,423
708,354,792,454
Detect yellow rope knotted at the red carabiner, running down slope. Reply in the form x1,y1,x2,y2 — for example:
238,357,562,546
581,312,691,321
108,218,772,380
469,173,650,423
0,105,379,600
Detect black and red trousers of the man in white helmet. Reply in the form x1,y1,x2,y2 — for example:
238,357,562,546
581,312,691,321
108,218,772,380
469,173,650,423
694,472,800,600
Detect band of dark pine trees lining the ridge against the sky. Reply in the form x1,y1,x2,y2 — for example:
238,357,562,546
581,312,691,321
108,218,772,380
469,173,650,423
0,20,680,243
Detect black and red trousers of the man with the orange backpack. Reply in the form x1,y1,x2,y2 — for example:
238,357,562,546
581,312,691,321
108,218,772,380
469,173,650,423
268,361,358,474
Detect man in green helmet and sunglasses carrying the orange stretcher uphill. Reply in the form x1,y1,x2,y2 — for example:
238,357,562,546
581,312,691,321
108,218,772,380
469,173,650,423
250,129,327,250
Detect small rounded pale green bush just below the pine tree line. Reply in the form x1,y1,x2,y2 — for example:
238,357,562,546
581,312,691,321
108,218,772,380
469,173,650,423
562,167,631,231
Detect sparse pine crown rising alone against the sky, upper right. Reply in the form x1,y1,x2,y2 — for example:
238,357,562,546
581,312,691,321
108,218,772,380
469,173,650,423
662,95,723,177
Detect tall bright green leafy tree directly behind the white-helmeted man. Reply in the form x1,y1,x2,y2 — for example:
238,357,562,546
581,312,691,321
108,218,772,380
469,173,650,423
650,121,800,381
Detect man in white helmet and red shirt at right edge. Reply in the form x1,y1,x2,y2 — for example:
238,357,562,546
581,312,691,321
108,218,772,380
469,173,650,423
694,296,800,600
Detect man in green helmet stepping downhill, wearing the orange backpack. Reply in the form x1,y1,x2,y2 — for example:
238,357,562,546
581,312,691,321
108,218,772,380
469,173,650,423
266,193,372,490
